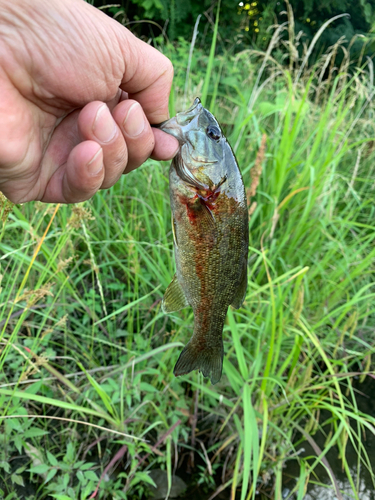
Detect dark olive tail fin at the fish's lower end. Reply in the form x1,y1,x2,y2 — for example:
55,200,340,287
173,341,224,384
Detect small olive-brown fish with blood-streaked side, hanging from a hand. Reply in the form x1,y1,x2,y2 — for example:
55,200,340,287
158,98,249,384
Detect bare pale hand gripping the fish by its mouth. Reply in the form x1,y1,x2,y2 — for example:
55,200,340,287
0,0,178,203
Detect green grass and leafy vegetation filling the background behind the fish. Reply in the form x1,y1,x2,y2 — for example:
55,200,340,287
0,0,375,500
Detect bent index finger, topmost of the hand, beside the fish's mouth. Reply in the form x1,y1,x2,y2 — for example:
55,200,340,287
120,31,173,123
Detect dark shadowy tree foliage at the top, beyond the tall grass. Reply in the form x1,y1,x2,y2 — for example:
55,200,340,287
91,0,375,53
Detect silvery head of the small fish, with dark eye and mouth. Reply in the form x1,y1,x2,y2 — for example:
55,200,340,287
159,97,226,169
